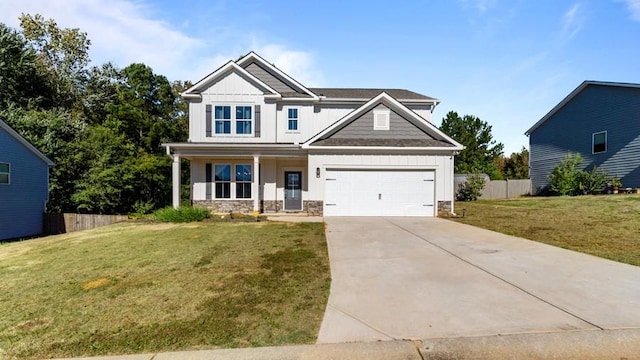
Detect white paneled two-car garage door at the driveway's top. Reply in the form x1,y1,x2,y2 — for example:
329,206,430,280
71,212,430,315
324,170,435,216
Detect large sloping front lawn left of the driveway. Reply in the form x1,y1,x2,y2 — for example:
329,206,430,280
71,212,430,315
0,222,330,359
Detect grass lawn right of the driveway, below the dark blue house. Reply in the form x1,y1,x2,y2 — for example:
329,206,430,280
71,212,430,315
455,195,640,266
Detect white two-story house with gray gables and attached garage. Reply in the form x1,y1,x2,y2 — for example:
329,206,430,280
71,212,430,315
164,52,463,216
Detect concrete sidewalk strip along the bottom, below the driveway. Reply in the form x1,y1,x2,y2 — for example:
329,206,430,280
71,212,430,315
53,329,640,360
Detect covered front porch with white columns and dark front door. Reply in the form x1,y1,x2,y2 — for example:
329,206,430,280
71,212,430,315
166,143,323,216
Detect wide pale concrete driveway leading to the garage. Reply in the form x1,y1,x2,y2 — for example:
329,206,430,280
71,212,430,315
318,217,640,343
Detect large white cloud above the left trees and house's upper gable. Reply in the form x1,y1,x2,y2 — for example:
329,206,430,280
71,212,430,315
0,0,322,86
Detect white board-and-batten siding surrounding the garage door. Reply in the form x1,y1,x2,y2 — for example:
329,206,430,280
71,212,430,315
307,152,453,208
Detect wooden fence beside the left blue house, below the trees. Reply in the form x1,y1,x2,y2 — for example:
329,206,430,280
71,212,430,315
44,213,129,235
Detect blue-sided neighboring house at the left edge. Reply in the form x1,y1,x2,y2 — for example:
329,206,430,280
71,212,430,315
0,120,53,240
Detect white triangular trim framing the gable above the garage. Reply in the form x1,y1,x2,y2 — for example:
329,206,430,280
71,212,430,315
302,92,464,151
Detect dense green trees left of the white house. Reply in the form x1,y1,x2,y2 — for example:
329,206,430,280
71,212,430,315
0,14,190,214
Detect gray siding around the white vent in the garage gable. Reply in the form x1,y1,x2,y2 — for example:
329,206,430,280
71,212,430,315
331,104,434,140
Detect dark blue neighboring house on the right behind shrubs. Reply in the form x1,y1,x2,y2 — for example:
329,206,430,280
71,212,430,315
525,81,640,194
